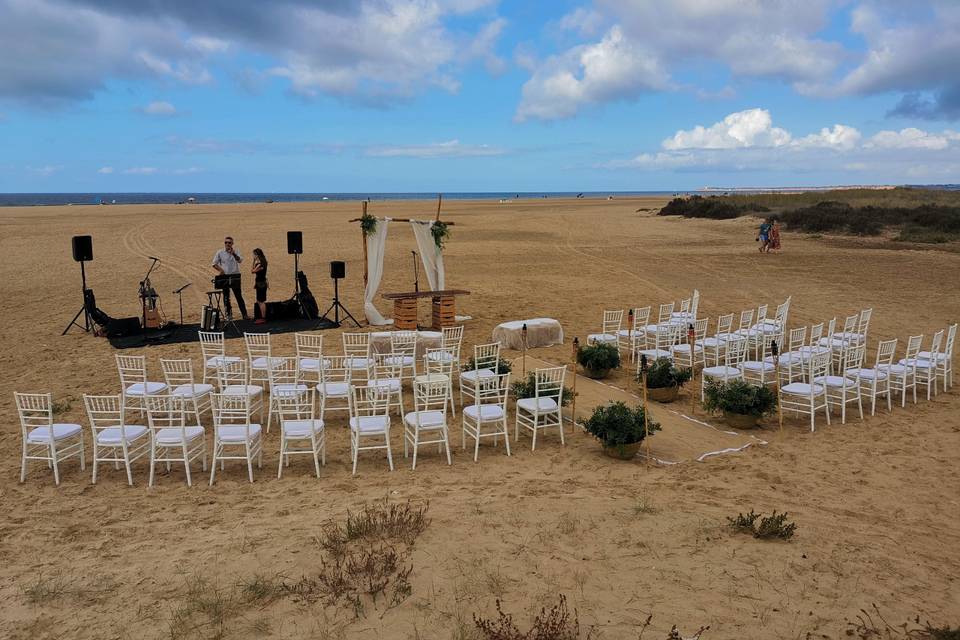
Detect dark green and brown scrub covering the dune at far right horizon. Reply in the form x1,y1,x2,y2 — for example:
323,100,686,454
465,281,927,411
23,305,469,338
658,188,960,243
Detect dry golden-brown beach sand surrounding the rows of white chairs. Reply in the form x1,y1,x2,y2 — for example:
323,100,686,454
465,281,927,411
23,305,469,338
0,199,960,639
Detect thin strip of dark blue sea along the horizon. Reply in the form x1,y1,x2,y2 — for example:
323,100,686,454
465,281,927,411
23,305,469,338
0,191,693,207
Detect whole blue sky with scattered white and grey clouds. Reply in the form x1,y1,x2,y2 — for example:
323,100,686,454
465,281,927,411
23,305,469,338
0,0,960,192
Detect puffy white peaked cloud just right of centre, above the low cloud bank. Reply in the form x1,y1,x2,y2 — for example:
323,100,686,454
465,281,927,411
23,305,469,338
516,26,669,121
